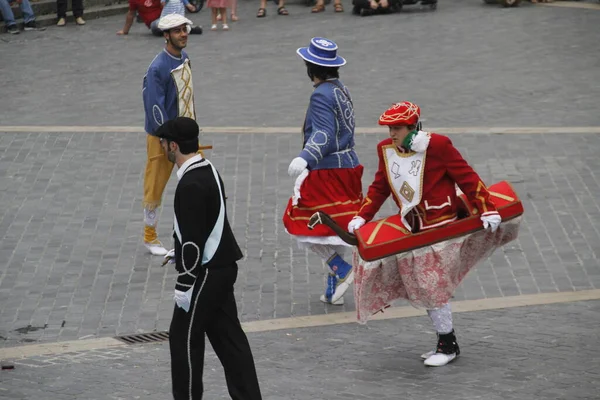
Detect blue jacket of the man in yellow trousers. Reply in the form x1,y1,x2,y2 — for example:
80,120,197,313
142,50,188,135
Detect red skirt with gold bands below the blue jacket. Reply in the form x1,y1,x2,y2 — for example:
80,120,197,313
283,165,363,236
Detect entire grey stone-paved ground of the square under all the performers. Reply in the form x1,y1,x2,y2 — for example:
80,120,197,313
0,0,600,400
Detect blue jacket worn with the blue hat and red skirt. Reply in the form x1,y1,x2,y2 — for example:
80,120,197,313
300,79,359,170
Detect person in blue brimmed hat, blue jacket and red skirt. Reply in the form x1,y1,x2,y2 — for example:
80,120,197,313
283,38,363,305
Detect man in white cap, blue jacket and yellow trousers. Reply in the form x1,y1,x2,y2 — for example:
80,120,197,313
142,14,196,256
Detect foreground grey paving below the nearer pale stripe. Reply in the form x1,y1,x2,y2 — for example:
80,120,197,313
0,301,600,400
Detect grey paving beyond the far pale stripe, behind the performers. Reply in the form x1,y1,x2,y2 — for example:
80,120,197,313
0,0,600,127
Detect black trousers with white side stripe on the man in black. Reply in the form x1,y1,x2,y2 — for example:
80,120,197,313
169,263,262,400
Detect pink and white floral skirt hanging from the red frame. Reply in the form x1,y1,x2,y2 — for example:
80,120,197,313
353,217,521,324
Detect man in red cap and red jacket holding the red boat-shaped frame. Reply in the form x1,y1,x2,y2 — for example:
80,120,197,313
348,101,502,366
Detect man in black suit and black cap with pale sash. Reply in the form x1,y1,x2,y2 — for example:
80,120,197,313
156,117,261,400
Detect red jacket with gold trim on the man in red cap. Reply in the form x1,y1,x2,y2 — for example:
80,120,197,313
357,133,496,231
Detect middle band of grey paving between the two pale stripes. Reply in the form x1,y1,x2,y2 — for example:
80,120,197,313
0,132,600,347
